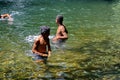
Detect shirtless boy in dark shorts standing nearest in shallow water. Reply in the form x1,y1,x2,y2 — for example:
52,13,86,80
32,26,51,64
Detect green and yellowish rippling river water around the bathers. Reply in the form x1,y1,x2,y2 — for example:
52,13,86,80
0,0,120,80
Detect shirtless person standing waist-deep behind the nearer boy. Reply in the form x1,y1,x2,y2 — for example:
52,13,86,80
52,15,68,47
